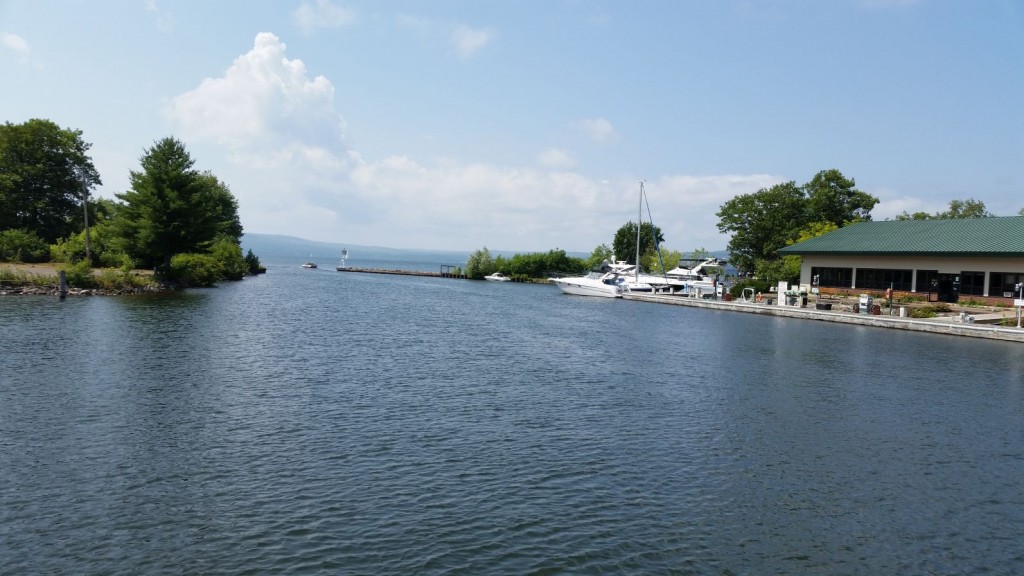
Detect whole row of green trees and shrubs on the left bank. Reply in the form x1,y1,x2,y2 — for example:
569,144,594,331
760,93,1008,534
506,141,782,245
0,119,262,286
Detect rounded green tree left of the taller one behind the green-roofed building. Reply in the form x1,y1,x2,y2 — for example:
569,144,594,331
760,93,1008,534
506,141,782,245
717,181,807,273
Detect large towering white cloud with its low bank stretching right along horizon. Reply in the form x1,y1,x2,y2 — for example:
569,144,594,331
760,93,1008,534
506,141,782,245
167,33,781,252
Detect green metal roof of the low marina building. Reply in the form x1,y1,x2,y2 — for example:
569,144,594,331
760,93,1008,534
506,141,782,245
778,216,1024,257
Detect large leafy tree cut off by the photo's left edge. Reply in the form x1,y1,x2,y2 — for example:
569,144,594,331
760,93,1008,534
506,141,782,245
0,119,102,244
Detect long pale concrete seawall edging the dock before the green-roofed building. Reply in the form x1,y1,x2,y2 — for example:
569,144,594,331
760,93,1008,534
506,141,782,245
624,294,1024,342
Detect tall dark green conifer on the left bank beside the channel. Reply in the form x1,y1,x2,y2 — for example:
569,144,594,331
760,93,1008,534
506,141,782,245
115,137,242,269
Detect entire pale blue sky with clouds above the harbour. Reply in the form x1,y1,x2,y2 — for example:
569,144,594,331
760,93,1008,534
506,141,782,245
0,0,1024,253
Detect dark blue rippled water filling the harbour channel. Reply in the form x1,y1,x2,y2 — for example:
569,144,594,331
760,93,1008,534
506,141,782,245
0,262,1024,575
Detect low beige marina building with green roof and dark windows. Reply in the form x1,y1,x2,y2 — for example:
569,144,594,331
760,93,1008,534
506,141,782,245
779,216,1024,302
